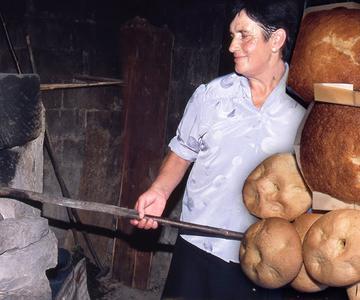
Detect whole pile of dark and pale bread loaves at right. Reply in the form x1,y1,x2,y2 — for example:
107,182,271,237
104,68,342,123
240,7,360,299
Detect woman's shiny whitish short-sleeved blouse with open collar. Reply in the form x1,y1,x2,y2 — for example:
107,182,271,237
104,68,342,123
169,65,305,262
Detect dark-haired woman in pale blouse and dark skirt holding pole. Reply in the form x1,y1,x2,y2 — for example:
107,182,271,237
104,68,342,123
131,0,305,299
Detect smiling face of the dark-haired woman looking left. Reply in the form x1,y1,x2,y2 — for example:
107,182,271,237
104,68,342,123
229,10,273,77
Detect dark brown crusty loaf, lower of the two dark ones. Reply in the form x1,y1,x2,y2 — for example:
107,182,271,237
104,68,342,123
300,102,360,203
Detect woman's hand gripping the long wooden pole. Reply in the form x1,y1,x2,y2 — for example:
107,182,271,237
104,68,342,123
130,186,168,229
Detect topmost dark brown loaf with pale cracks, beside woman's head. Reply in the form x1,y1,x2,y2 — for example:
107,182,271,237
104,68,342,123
288,7,360,101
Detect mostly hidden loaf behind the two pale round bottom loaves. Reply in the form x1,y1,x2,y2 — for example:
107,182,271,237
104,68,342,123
290,214,327,293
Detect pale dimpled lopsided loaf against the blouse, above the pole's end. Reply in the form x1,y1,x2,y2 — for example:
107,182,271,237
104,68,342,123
243,153,311,221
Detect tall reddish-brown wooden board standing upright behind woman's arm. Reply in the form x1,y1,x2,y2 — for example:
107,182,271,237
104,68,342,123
112,18,173,289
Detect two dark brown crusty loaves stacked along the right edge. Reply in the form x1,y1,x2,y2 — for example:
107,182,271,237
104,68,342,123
288,6,360,203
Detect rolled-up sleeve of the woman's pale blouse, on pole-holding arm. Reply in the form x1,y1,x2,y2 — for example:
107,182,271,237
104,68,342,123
169,85,205,161
